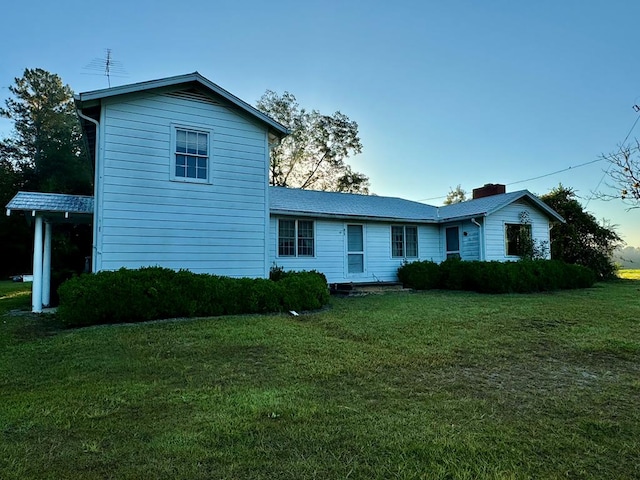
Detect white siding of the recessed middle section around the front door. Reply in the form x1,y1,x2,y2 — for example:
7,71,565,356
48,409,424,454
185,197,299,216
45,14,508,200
269,217,440,283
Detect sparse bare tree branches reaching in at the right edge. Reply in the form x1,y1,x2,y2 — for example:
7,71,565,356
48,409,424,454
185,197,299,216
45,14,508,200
600,140,640,208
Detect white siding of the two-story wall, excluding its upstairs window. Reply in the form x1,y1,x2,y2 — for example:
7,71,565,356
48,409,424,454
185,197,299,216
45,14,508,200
96,93,269,277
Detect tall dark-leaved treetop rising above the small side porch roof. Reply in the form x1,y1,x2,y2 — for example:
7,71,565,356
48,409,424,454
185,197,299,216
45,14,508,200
0,68,92,194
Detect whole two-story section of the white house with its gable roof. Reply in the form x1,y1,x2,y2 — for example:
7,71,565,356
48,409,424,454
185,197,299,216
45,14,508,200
75,73,288,277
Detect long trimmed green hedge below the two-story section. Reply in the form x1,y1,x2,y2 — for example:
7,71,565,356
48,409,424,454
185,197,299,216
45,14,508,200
58,267,329,326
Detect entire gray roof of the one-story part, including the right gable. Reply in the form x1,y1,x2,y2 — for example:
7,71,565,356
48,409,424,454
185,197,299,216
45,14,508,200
269,187,564,223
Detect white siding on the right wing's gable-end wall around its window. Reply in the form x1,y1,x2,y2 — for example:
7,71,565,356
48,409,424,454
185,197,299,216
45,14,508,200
485,200,549,262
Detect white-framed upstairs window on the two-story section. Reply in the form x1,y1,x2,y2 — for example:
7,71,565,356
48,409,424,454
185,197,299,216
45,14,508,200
171,127,211,183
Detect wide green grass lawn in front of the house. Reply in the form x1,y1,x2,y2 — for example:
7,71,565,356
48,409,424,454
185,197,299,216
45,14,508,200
0,280,640,479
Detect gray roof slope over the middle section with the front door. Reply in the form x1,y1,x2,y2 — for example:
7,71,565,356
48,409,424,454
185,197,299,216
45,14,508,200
269,187,437,223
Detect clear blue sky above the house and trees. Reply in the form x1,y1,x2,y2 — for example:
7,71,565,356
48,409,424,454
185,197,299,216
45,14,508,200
0,0,640,246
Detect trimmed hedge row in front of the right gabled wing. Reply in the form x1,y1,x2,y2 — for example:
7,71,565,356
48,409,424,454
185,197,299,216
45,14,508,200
398,259,596,293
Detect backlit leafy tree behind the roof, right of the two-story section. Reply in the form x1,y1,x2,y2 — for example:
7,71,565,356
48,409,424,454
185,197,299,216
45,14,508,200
257,90,369,194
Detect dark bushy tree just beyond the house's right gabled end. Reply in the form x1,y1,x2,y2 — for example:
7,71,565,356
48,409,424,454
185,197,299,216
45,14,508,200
540,185,622,279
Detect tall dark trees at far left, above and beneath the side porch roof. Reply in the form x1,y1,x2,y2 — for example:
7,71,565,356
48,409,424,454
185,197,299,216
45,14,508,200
0,68,92,277
